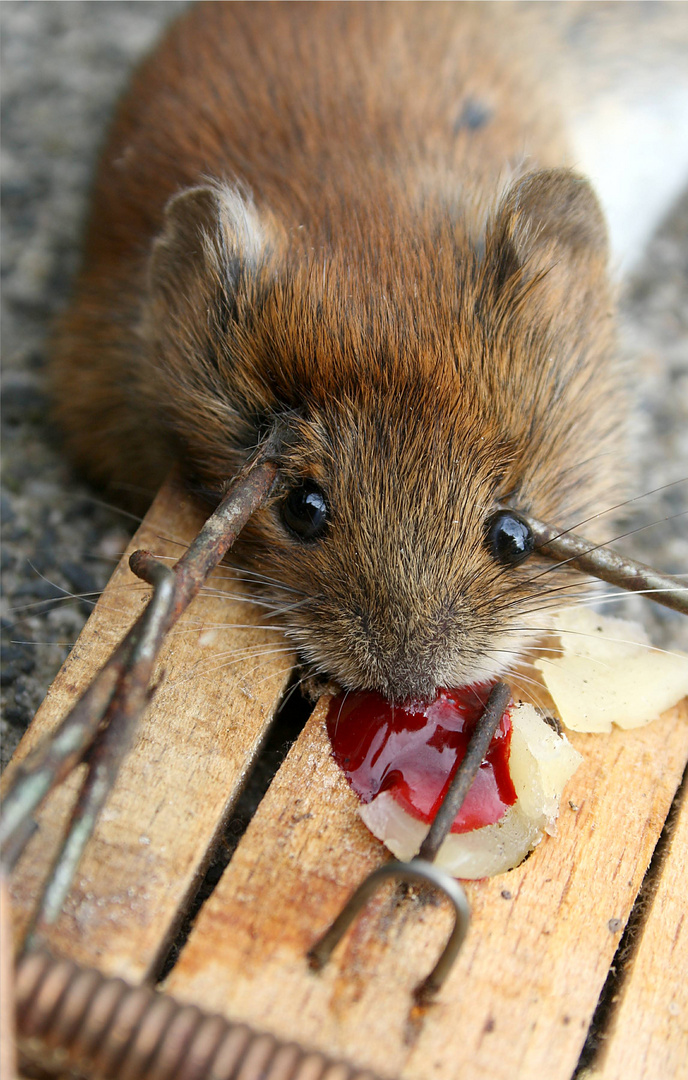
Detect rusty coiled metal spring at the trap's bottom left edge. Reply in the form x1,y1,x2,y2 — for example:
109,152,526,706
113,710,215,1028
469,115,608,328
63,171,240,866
15,951,375,1080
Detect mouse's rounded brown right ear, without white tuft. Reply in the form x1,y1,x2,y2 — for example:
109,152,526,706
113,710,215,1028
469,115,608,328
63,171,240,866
494,168,608,281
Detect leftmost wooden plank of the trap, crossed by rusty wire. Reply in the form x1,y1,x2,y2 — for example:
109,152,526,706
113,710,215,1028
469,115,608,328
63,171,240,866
8,482,293,982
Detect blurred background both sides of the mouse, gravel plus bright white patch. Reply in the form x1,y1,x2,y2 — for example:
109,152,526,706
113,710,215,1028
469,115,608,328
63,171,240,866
0,6,688,765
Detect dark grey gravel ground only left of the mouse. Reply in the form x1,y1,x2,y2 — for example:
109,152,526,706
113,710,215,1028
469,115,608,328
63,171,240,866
0,0,184,766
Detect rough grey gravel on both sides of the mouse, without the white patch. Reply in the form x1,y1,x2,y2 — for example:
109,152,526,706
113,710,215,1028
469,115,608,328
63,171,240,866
0,0,688,765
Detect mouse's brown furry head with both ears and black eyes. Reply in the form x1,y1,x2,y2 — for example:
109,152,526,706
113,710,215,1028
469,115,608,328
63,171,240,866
144,171,619,699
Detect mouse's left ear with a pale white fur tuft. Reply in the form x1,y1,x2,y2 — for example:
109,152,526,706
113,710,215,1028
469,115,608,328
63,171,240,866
148,184,267,322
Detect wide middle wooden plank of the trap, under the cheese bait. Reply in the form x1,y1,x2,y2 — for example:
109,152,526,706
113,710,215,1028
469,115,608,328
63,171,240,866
167,702,688,1080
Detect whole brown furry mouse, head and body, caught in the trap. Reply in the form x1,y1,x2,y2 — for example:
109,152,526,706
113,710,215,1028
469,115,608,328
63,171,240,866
54,3,626,700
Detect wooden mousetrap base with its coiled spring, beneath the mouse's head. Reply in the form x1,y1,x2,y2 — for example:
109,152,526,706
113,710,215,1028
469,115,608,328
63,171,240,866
3,470,688,1080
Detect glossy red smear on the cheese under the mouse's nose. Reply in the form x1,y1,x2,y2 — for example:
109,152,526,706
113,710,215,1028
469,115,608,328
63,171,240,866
327,685,516,833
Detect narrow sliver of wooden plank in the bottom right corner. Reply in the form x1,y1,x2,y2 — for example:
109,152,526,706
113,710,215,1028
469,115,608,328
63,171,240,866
586,785,688,1080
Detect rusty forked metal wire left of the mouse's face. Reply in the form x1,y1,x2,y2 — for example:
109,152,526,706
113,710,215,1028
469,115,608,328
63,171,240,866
0,432,280,945
